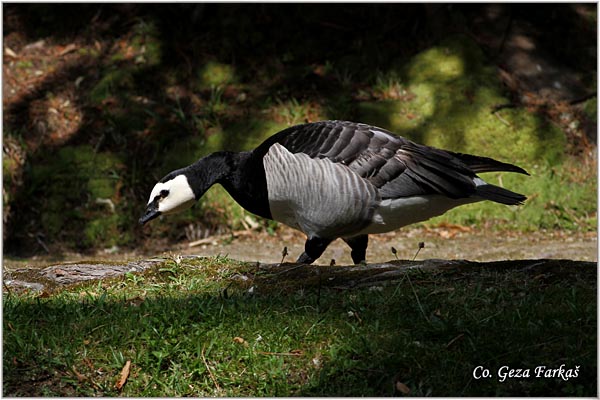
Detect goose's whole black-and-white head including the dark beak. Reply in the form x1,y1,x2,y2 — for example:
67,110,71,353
140,172,196,225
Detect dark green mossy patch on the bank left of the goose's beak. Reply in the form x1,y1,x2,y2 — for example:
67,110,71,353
30,145,124,247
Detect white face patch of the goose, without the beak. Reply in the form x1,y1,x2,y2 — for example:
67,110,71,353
148,175,196,214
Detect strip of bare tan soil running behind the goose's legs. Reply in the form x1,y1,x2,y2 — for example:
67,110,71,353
4,224,598,271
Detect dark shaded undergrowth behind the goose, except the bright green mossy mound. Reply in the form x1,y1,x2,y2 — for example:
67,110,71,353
3,4,597,255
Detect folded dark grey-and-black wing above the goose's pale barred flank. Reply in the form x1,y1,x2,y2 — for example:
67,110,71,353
261,121,510,199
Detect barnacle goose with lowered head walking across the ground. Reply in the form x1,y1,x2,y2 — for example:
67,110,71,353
139,121,528,264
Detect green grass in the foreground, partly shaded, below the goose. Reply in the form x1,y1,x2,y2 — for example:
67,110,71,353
3,257,597,397
